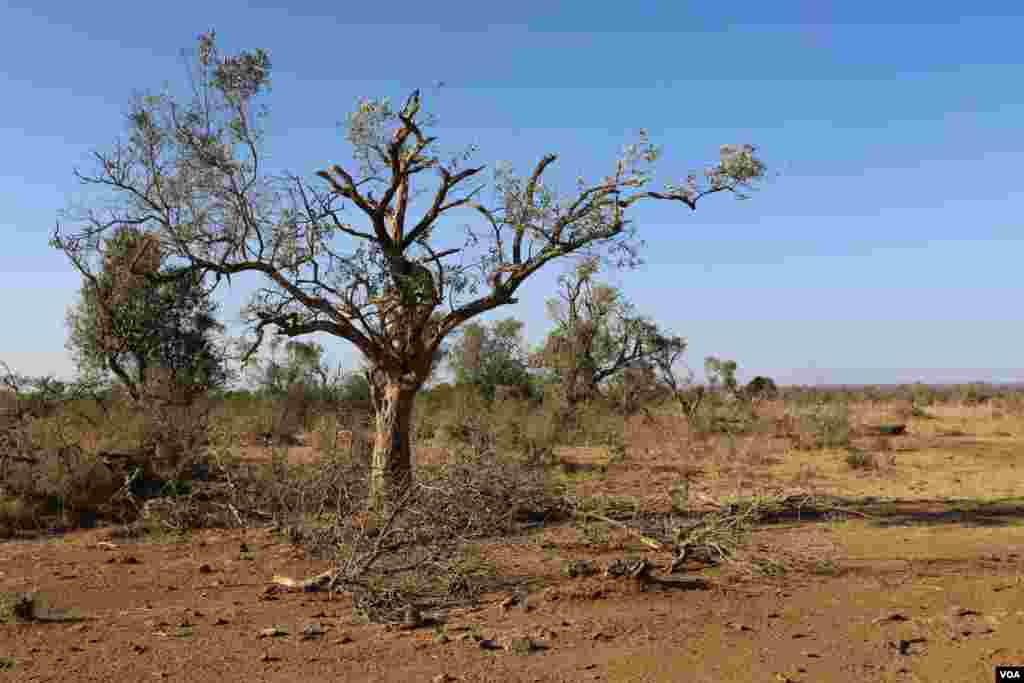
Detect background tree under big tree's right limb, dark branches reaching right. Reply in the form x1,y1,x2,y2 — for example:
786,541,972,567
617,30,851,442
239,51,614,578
532,258,685,408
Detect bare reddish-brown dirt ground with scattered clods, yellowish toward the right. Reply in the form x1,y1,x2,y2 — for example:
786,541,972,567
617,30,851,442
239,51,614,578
0,407,1024,683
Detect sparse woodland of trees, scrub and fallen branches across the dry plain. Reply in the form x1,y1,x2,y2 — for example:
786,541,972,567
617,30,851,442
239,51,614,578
0,33,1024,679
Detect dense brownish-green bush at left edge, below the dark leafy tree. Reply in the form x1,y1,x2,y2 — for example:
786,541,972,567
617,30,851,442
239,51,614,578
0,368,221,530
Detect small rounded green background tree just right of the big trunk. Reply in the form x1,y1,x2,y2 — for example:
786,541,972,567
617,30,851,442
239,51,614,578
449,317,529,400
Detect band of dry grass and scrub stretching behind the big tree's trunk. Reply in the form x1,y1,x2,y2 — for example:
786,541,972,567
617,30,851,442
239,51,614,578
6,385,1024,577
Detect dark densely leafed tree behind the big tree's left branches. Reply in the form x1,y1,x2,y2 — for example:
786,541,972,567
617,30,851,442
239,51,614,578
66,225,228,404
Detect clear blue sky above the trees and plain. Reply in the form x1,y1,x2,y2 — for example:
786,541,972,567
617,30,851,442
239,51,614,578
0,0,1024,383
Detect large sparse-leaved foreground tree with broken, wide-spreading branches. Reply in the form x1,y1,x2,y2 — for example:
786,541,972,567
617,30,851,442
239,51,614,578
53,33,764,507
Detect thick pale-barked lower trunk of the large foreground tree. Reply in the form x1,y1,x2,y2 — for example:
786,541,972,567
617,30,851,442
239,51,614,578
369,381,417,512
